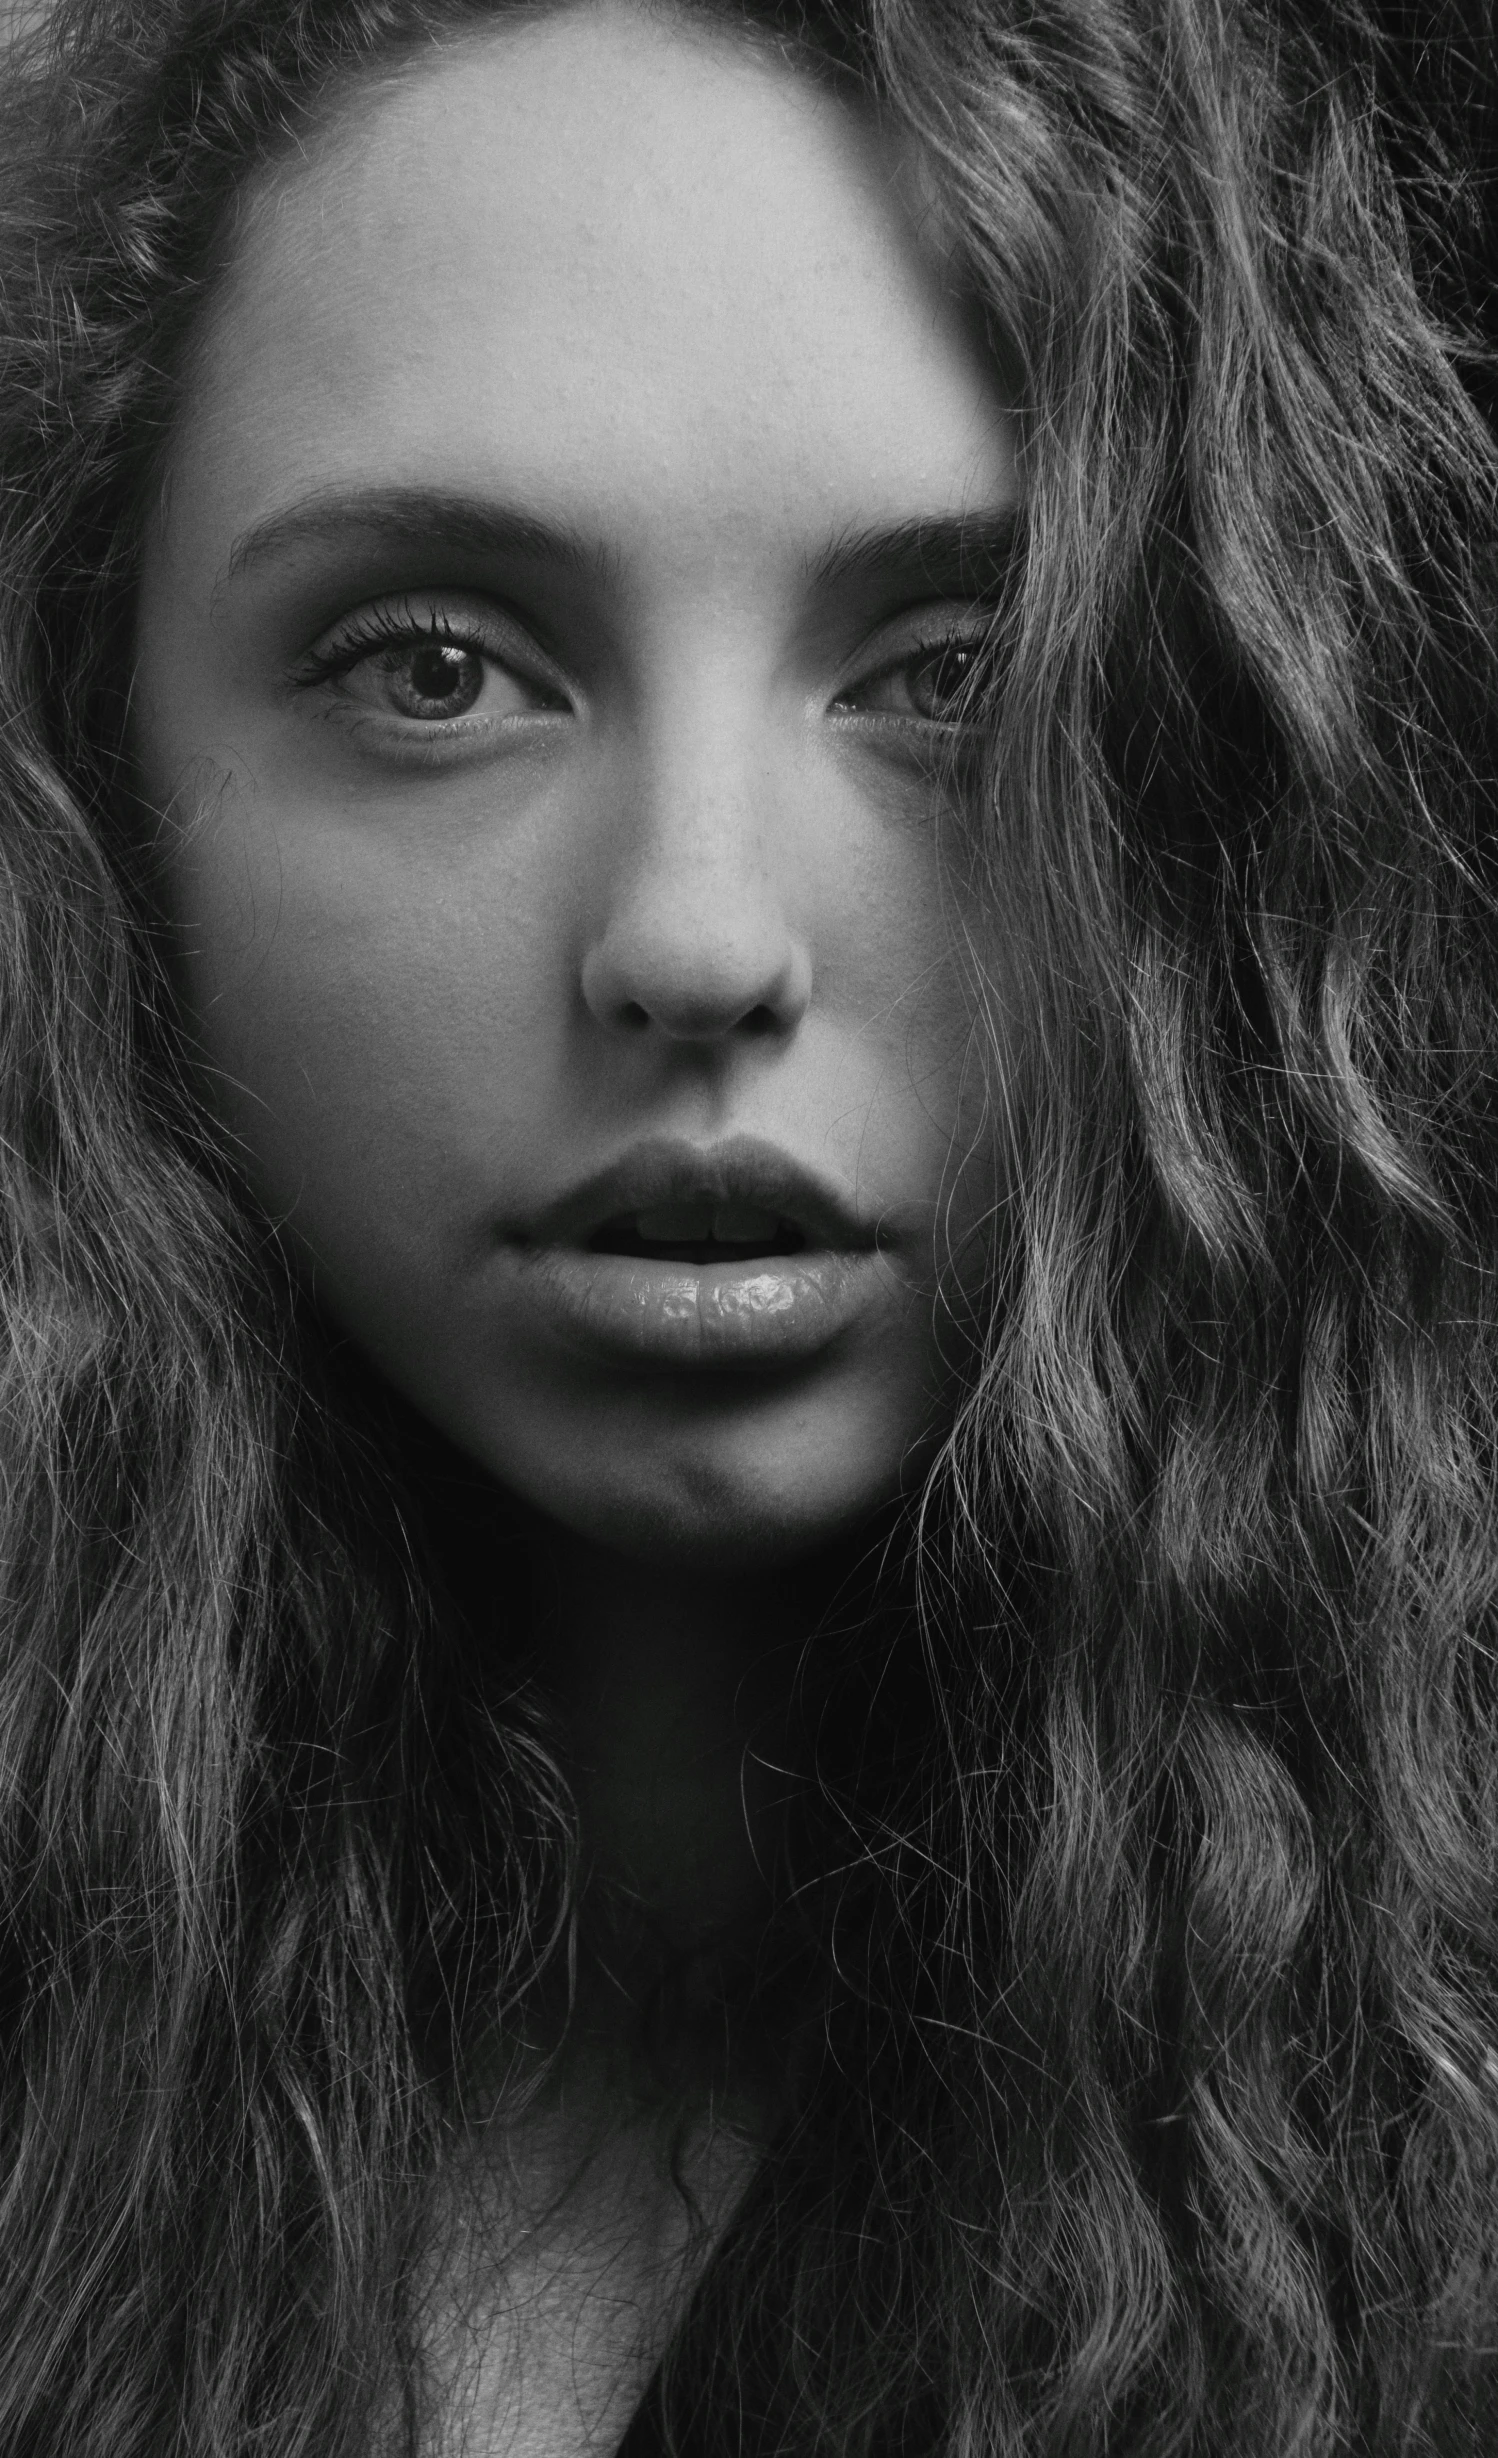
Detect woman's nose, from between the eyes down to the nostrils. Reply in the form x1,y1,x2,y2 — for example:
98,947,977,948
583,735,812,1042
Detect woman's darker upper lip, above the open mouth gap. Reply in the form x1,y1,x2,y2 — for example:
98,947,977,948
511,1136,876,1249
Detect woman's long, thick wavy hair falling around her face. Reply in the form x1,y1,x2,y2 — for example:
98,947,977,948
0,0,1498,2458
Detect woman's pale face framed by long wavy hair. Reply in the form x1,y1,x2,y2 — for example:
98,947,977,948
135,5,1016,1566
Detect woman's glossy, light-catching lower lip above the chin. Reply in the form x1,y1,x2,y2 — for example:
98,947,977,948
509,1246,878,1367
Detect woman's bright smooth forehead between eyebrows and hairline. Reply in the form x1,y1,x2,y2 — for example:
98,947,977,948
157,0,1011,589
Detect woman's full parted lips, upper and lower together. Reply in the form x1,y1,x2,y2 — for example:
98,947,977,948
504,1136,883,1372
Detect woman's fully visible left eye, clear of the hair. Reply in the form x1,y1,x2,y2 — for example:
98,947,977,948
295,602,571,725
